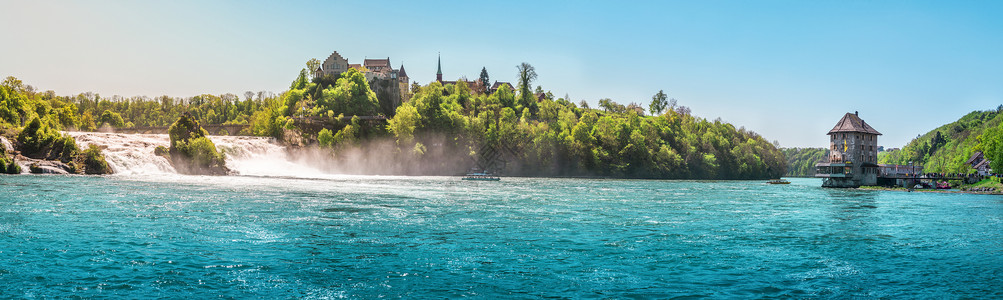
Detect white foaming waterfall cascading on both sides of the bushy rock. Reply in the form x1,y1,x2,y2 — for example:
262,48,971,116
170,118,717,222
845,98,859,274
66,132,323,177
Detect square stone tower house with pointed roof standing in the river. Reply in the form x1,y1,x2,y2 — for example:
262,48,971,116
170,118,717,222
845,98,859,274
815,111,881,188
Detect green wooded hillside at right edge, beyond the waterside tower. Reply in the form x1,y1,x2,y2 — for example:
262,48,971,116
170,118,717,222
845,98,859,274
878,105,1003,173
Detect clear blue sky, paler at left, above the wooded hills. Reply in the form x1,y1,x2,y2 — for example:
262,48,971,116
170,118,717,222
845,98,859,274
0,0,1003,146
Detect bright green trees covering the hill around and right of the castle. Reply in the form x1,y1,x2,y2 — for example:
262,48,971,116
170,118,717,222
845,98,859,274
252,63,786,179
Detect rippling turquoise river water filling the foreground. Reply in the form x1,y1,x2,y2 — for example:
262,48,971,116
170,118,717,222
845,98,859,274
0,176,1003,298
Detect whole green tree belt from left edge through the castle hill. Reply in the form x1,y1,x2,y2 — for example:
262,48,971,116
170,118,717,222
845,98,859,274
0,60,787,180
